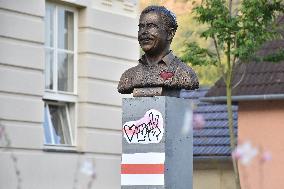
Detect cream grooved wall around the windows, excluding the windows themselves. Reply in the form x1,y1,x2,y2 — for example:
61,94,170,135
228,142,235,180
0,0,139,189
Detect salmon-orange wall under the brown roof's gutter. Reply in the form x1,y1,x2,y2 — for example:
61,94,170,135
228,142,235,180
238,100,284,189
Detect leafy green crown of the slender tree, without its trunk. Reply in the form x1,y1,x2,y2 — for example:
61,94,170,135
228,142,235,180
189,0,284,64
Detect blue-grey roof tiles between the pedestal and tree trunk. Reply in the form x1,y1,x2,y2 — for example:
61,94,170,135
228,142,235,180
181,88,238,158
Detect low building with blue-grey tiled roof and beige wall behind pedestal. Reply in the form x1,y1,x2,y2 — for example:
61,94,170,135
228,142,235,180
181,88,235,189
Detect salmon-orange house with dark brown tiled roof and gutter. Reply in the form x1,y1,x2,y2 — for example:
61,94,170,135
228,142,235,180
206,38,284,189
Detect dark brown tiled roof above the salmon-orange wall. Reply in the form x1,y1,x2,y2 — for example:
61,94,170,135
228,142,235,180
205,61,284,97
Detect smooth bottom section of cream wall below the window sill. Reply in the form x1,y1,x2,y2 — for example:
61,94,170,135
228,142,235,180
0,149,120,189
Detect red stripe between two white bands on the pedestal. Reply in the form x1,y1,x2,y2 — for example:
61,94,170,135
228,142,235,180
121,164,164,174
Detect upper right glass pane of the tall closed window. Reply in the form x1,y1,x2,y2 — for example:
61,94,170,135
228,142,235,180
58,9,74,50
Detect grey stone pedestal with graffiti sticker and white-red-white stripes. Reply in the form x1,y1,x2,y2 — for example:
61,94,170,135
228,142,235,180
121,96,193,189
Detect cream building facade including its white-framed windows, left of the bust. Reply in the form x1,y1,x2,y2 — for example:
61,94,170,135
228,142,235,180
0,0,139,189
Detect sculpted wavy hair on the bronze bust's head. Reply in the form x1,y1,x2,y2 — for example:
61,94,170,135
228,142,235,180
141,6,178,35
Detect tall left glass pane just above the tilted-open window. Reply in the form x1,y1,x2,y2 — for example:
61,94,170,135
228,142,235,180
44,49,54,89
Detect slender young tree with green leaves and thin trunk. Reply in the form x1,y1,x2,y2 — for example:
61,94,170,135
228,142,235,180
182,0,284,189
